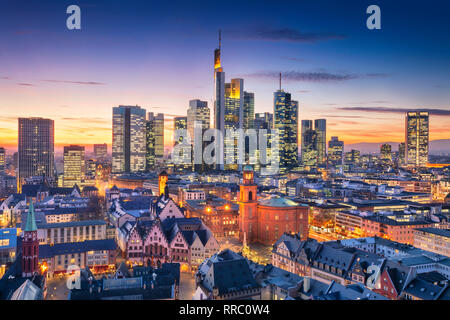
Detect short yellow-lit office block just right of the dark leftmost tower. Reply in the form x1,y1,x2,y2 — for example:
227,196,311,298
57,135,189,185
63,145,85,188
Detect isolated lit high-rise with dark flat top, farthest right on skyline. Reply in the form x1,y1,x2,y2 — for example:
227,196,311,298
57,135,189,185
405,111,429,167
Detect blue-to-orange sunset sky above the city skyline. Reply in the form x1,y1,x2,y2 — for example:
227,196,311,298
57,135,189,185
0,0,450,154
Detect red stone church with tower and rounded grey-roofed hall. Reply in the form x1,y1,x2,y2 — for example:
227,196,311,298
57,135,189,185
238,166,308,245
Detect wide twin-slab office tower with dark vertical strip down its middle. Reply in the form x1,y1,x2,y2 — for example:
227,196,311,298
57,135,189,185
112,106,146,173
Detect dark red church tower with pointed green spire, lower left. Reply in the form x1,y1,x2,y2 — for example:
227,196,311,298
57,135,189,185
22,198,39,278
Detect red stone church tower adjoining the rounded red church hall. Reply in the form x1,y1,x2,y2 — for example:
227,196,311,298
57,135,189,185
239,165,258,243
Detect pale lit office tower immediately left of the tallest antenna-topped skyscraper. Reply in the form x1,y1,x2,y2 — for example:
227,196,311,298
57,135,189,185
187,99,211,172
